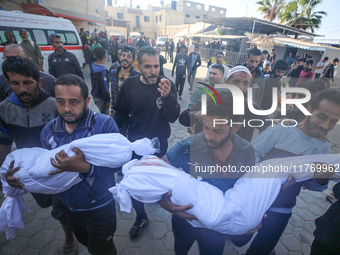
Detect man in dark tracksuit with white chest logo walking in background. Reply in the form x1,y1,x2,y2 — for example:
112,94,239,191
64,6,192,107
171,44,190,99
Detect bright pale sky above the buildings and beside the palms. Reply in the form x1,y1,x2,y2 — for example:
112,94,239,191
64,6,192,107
117,0,340,41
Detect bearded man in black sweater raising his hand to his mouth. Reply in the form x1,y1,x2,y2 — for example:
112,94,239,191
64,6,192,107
113,47,180,237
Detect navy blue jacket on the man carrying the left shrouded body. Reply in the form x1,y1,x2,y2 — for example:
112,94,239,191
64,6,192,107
40,109,119,211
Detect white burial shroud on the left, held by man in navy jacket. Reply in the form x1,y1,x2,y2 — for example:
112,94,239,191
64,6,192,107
0,134,159,239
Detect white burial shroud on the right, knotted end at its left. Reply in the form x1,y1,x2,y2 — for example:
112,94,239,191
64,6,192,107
110,154,340,235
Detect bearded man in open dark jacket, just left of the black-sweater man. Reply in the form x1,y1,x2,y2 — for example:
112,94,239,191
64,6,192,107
110,46,139,117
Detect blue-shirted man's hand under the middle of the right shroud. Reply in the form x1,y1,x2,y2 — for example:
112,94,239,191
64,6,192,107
158,191,198,221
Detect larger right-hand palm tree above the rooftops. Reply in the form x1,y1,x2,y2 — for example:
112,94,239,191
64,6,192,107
278,0,327,33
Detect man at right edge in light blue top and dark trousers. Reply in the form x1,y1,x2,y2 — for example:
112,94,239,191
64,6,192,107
246,89,340,255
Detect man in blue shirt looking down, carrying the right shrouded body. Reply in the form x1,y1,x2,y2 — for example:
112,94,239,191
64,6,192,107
159,91,255,255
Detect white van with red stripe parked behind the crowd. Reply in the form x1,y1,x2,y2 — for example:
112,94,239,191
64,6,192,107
0,11,85,73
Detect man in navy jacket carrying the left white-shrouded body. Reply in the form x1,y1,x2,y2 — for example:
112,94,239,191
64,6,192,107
40,74,119,255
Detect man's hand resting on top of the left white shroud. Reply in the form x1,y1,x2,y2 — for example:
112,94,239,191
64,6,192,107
49,148,91,175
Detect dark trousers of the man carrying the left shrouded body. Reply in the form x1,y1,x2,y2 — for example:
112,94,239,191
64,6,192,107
64,201,117,255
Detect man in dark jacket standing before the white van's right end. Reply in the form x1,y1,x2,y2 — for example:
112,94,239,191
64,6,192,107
48,34,84,79
